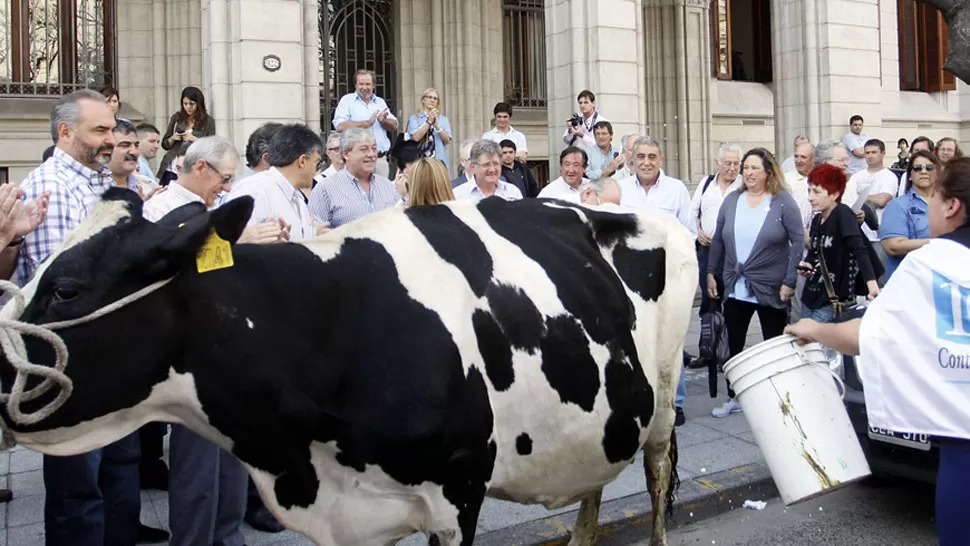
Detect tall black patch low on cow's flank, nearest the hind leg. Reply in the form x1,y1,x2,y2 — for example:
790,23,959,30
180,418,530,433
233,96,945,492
603,344,654,463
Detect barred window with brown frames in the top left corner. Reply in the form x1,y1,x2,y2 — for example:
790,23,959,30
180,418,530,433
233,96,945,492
0,0,116,95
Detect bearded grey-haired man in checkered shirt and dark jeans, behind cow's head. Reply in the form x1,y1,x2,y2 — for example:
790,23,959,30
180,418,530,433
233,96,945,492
17,89,168,546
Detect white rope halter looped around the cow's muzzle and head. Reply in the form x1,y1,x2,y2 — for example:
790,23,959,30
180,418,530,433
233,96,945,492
0,277,175,449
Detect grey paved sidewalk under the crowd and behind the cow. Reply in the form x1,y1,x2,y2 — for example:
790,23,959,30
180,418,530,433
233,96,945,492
0,307,764,546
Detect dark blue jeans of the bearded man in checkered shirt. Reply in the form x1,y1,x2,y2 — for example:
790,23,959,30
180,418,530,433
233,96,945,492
43,433,141,546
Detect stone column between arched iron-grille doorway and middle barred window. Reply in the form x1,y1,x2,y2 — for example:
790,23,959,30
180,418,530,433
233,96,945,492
396,0,502,171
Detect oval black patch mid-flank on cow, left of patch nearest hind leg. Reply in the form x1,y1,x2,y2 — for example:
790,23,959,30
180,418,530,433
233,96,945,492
539,315,600,411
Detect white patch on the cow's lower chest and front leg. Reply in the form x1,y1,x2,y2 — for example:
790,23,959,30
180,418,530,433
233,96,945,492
246,442,461,546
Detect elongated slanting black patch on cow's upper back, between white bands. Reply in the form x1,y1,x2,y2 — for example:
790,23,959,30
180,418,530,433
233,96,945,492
405,205,492,298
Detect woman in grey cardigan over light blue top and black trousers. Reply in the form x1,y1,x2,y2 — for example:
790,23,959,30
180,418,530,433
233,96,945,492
707,148,805,417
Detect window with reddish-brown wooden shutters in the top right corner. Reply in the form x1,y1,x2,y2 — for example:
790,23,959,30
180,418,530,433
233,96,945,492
896,0,957,93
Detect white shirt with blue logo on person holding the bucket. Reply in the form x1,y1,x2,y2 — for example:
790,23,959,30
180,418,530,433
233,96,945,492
857,239,970,439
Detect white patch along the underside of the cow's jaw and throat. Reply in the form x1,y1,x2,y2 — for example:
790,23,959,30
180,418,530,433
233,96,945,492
14,369,232,456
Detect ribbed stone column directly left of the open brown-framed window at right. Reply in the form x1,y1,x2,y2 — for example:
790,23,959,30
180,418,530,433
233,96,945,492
643,0,713,185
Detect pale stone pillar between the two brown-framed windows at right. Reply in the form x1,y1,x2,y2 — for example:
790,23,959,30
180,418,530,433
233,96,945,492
771,0,882,153
